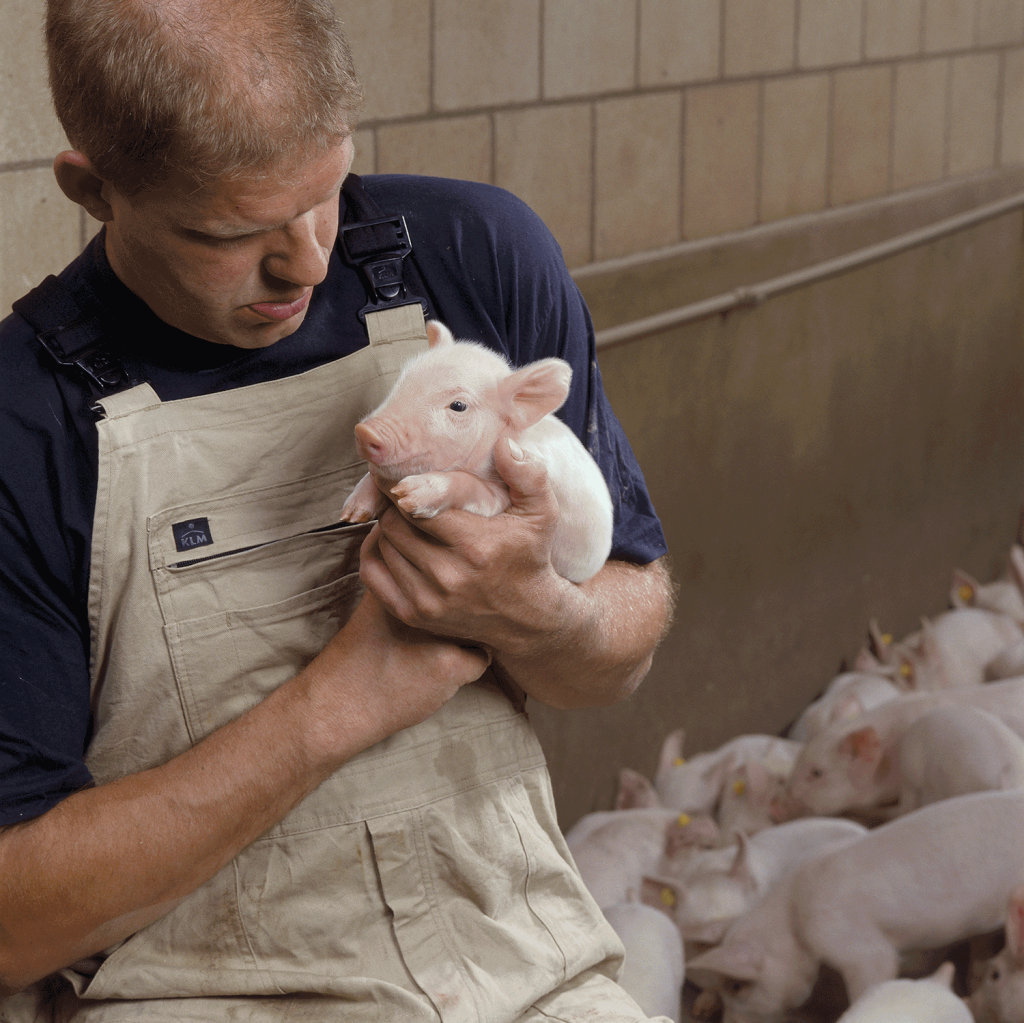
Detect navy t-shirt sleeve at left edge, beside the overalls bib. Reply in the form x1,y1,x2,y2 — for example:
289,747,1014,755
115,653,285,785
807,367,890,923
0,316,92,824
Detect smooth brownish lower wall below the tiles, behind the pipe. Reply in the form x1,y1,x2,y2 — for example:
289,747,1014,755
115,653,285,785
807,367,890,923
532,169,1024,823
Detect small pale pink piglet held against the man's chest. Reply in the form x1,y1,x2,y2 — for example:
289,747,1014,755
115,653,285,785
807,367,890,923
342,321,612,583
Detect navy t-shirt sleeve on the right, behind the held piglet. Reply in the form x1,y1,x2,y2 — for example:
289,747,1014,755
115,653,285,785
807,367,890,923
376,176,668,564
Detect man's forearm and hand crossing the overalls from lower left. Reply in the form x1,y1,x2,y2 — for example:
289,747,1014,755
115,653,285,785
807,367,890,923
0,596,486,995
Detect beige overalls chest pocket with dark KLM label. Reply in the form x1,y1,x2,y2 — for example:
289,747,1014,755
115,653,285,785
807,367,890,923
147,463,370,742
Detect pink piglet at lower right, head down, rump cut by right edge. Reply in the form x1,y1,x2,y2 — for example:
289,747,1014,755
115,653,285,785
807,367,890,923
687,791,1024,1023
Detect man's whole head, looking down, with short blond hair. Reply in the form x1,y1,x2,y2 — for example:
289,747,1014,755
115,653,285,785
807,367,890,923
47,0,360,348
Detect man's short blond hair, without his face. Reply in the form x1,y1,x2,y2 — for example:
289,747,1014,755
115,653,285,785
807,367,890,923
46,0,362,194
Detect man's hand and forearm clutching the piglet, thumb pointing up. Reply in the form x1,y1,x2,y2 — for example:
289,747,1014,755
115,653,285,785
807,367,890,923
360,440,671,707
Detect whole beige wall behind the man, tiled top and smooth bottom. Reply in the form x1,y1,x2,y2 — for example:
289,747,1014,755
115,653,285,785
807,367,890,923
0,0,1024,823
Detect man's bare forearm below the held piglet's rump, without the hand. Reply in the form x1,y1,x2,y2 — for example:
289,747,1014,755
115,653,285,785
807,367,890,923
496,558,672,710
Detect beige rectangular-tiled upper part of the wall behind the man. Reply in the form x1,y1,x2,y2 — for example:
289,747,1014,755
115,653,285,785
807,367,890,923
0,0,1024,308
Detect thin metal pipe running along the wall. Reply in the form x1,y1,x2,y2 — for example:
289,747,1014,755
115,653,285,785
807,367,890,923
595,191,1024,348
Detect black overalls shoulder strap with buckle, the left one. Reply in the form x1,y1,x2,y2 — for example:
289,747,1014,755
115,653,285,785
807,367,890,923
13,274,138,399
